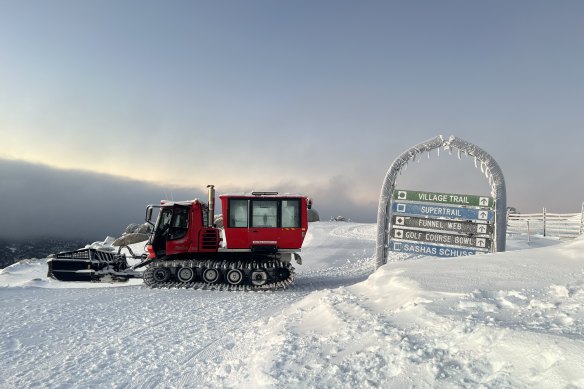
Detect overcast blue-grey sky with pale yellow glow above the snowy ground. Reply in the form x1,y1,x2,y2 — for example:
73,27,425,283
0,0,584,239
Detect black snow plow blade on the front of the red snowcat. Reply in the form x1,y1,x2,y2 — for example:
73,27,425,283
47,248,141,281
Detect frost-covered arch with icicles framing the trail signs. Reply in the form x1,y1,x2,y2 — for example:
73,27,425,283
375,135,507,268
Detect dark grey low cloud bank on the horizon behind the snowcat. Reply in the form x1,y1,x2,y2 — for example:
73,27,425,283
0,159,376,241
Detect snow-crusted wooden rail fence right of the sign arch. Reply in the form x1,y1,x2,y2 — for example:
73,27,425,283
507,203,584,240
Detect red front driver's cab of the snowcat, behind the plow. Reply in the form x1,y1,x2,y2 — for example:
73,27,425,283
147,200,219,258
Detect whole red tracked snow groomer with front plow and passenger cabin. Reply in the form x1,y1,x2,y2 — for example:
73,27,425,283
49,185,311,290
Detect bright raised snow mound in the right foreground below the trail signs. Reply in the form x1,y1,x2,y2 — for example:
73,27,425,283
214,230,584,388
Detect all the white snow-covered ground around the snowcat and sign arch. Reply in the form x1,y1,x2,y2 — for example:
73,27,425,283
0,222,584,389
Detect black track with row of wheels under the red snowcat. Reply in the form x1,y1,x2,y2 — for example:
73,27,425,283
144,259,294,291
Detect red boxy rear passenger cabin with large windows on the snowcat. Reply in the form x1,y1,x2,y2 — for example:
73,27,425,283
219,192,308,253
